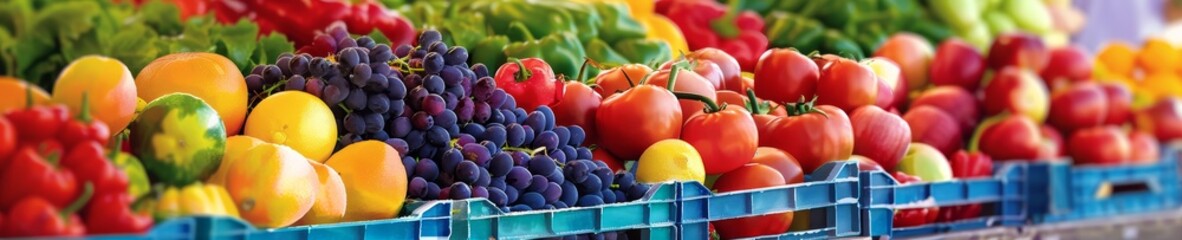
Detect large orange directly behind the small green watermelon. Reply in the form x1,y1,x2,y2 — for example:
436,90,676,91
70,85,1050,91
136,52,247,135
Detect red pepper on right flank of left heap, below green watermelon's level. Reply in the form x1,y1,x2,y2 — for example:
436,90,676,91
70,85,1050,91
61,141,128,200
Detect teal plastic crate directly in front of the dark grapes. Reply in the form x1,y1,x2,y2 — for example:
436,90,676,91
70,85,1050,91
452,180,680,239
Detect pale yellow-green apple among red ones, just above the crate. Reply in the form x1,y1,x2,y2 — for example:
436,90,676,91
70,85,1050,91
898,143,953,182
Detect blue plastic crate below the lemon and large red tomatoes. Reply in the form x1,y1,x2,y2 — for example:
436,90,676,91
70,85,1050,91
677,161,860,240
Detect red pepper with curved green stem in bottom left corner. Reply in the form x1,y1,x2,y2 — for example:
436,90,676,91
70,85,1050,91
0,184,93,236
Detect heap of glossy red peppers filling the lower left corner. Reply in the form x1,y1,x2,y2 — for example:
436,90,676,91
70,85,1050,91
0,102,152,236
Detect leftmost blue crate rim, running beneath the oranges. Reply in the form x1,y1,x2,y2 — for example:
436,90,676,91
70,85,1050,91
89,201,452,240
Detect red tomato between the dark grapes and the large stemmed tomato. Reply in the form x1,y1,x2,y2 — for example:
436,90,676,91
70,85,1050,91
551,82,603,143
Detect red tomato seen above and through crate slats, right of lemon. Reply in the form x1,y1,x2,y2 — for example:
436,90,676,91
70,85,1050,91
713,163,793,239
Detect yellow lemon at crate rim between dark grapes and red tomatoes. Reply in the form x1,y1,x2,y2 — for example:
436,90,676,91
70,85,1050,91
636,140,706,183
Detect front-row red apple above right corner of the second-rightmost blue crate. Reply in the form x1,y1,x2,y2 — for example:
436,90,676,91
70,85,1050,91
978,115,1044,161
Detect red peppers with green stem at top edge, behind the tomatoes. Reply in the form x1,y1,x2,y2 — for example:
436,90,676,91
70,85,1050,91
656,0,767,72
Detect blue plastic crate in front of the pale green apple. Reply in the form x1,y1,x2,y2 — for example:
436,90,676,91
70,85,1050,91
859,165,1026,238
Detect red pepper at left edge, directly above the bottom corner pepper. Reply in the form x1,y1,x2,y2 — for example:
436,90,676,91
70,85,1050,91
0,148,78,209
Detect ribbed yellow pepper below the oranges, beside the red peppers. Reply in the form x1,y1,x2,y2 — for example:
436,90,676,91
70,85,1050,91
154,182,239,220
